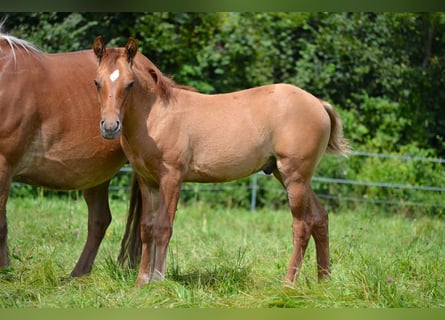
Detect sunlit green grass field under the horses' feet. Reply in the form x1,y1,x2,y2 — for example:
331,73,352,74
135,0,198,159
0,197,445,308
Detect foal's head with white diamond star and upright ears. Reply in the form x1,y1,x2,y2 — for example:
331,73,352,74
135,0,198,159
93,36,137,139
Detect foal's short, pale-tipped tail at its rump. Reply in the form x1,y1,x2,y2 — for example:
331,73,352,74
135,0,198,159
320,100,350,155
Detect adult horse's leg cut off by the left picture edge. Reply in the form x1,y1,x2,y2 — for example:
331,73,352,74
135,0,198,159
0,156,12,269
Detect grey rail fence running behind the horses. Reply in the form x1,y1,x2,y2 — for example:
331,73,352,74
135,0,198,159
13,152,445,211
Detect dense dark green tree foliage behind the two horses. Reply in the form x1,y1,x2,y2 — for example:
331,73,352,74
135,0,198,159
3,12,445,212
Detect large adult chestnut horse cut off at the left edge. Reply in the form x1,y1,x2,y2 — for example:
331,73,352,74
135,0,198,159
0,33,127,276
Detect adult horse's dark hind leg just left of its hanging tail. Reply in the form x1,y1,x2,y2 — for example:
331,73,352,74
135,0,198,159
71,181,111,277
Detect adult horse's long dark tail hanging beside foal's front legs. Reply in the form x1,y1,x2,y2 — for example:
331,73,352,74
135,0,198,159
117,174,142,268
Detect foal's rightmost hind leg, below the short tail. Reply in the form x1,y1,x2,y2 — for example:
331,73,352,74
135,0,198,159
309,189,331,280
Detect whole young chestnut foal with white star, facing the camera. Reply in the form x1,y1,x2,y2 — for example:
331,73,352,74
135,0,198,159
93,36,348,286
